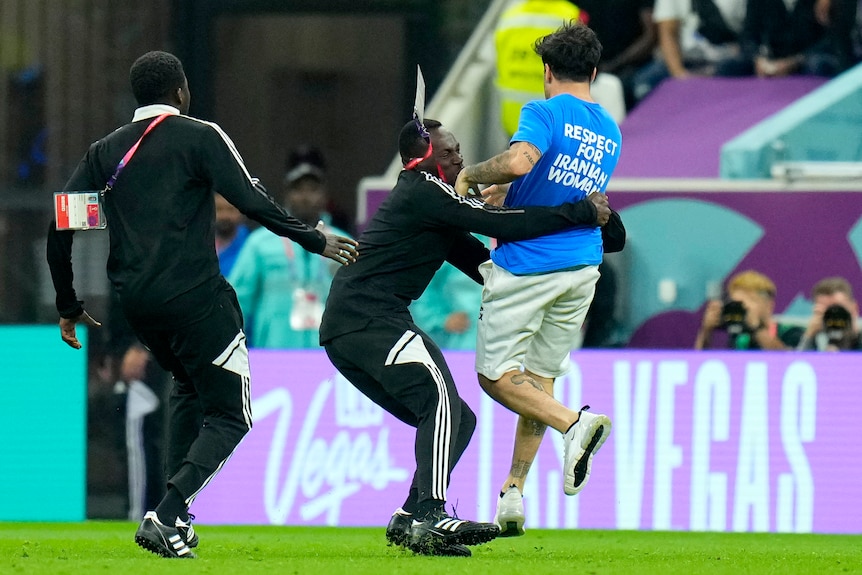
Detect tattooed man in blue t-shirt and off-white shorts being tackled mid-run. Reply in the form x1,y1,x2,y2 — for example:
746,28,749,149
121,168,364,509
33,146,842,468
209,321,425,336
455,23,622,536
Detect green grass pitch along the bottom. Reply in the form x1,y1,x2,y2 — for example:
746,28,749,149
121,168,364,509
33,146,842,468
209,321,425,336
0,521,862,575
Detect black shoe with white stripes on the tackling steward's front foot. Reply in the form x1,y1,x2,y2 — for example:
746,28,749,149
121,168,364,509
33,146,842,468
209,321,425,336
407,508,500,555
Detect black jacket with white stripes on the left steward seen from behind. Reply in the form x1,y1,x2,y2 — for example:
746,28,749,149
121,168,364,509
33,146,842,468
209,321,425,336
47,104,326,328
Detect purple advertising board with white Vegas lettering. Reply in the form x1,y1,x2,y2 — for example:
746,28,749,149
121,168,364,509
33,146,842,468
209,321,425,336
192,350,862,533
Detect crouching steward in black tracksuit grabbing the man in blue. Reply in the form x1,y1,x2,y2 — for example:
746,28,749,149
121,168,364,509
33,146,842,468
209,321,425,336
320,119,610,555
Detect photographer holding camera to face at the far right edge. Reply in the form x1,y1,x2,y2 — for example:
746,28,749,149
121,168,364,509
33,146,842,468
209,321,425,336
797,277,862,351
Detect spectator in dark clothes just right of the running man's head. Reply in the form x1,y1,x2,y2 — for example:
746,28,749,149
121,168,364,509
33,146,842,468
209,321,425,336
576,0,658,110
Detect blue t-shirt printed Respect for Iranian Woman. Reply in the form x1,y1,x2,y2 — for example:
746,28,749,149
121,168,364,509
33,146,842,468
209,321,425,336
491,94,622,275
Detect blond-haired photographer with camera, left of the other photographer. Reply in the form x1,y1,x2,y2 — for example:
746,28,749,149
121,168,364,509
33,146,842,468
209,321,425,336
694,270,802,350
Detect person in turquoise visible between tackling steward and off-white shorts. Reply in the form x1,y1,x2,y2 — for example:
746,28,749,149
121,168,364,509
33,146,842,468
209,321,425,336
410,234,489,349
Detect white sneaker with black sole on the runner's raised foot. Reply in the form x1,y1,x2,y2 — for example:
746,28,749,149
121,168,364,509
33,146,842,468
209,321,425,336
563,405,611,495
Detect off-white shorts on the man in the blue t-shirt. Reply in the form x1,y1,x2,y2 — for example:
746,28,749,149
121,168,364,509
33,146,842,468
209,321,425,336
476,260,600,381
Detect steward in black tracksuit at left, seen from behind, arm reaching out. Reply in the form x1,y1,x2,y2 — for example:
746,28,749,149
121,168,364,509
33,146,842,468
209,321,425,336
47,52,357,557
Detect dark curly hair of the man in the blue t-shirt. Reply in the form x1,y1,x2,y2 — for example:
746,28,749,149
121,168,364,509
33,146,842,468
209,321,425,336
533,20,602,82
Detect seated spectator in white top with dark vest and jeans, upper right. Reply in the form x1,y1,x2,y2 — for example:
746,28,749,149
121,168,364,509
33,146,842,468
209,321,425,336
634,0,748,100
